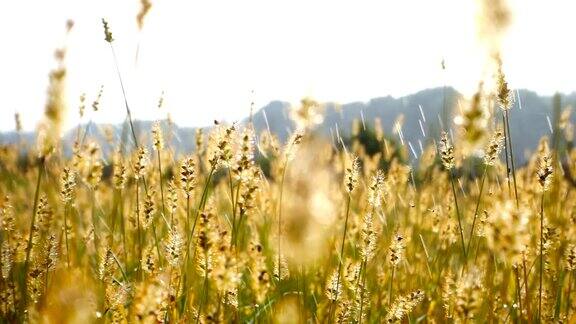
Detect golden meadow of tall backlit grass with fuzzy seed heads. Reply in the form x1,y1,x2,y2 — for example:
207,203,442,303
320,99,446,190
0,15,576,323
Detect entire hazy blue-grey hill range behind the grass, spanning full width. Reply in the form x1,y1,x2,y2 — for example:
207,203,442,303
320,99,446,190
0,87,576,163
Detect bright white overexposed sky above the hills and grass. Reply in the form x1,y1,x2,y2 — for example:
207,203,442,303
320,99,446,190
0,0,576,130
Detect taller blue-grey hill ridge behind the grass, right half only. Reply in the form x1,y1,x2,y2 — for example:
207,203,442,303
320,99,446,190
253,88,576,163
